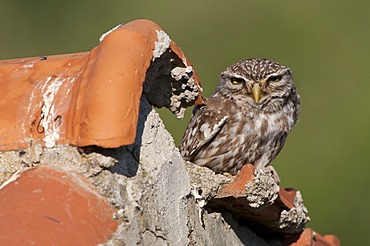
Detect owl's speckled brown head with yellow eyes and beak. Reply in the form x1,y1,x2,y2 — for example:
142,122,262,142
214,58,299,105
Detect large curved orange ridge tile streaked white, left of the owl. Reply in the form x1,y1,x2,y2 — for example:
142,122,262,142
0,20,202,150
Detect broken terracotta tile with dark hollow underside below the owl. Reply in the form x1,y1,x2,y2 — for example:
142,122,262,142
208,164,340,246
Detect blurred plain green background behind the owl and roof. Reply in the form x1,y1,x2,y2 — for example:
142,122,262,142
0,0,370,245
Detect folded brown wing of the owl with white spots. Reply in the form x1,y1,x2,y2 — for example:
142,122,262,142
180,102,229,159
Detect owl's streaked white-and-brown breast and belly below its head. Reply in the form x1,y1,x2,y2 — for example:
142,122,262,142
185,96,295,175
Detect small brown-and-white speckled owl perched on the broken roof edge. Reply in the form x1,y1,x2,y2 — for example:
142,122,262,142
180,58,300,175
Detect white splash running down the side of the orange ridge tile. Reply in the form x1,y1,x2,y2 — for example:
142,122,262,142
40,77,66,148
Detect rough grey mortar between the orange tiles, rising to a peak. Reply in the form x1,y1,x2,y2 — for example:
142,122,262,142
0,96,272,245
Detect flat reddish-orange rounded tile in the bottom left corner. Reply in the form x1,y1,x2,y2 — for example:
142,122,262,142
0,165,118,245
